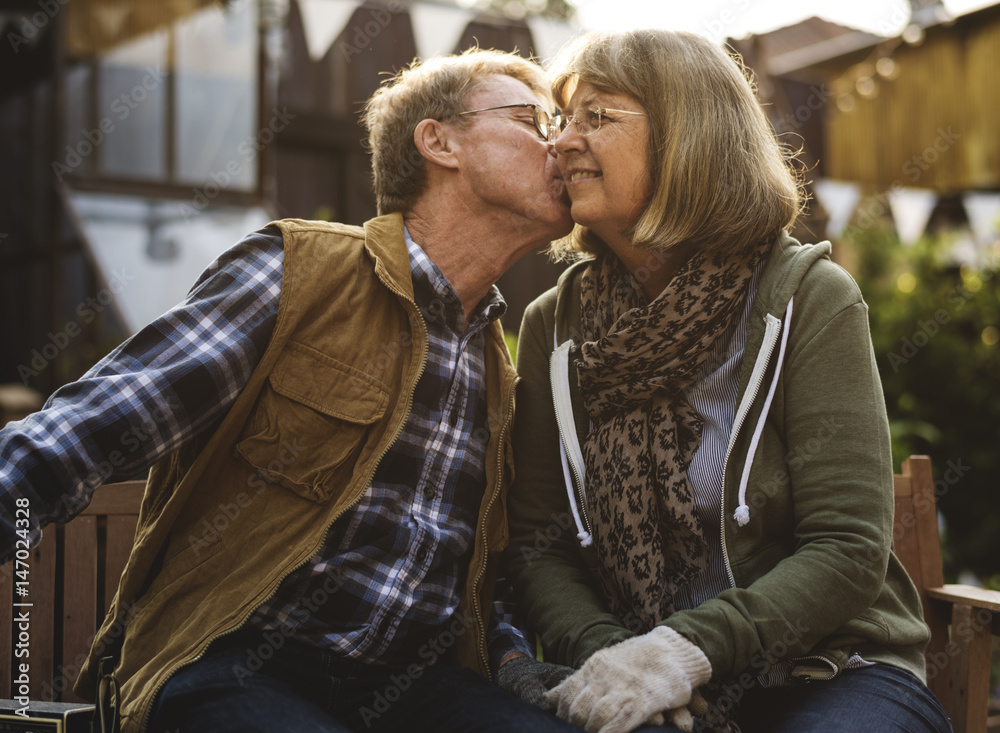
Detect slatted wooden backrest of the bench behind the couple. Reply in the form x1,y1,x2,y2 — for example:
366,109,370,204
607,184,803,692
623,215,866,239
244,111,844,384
0,456,984,712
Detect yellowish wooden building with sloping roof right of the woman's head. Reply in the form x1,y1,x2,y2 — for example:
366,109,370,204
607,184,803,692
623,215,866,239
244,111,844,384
733,0,1000,249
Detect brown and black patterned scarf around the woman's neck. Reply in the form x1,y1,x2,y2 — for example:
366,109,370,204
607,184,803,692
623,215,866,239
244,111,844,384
577,243,769,630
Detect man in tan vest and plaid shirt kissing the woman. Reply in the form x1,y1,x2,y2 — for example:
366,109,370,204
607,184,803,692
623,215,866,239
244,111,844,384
0,51,576,733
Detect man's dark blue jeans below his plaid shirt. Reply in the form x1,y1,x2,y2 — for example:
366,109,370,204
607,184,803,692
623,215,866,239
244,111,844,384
150,635,581,733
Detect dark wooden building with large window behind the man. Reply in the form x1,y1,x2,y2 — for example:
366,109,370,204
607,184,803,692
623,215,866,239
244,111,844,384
0,0,573,394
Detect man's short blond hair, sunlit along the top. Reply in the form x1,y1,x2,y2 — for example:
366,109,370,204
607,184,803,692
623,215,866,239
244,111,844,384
363,48,552,214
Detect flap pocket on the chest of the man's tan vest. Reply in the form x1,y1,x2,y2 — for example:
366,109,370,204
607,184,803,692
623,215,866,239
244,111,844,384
236,343,389,502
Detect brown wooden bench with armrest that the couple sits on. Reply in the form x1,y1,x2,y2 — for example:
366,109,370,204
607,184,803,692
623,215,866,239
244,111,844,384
0,456,1000,733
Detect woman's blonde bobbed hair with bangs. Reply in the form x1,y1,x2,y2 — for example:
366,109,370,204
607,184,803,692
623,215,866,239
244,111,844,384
550,30,802,259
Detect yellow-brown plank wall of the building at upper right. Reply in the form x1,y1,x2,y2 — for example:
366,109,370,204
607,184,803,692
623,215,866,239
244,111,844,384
824,6,1000,192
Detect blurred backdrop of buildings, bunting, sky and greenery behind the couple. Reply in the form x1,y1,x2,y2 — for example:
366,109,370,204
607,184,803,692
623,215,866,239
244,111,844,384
0,0,1000,692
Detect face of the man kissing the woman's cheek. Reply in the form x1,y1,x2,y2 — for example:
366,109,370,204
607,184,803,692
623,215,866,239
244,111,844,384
446,76,573,244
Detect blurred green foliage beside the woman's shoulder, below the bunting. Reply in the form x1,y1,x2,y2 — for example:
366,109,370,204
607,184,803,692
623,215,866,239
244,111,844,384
845,223,1000,578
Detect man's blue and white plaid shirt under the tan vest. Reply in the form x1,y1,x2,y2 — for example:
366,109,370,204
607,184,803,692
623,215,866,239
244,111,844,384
0,228,532,669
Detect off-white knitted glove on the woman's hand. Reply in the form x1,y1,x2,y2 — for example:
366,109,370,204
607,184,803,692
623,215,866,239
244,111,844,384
545,626,712,733
